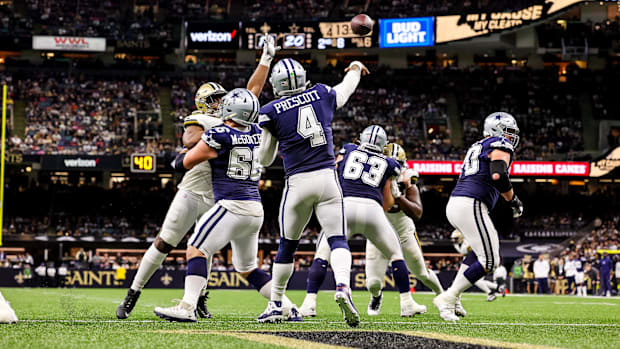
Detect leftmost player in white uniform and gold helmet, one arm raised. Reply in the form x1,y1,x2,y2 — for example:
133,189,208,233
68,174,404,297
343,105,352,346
116,38,277,319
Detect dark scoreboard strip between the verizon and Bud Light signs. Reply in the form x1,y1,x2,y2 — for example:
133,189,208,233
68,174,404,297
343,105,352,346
242,22,378,50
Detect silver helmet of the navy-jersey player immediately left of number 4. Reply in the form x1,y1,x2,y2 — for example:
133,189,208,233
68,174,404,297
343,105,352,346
219,88,260,126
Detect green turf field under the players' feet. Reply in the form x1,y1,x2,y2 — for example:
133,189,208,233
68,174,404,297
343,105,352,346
0,288,620,349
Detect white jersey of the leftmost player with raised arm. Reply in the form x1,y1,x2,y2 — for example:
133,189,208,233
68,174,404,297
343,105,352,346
178,112,222,201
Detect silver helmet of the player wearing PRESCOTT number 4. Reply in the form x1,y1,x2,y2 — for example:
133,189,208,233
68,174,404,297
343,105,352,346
269,58,310,97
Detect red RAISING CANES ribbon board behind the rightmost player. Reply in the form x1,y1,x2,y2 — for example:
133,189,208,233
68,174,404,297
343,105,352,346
407,161,590,177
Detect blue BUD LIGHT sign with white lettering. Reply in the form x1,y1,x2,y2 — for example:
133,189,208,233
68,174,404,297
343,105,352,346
379,17,435,48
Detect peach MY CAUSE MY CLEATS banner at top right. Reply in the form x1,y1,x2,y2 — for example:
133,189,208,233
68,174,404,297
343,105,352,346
435,0,585,44
